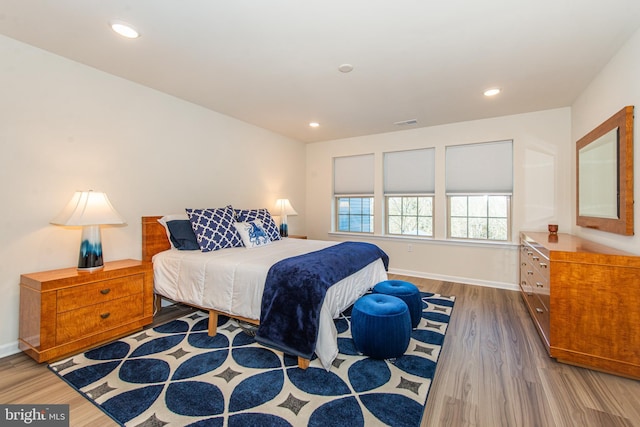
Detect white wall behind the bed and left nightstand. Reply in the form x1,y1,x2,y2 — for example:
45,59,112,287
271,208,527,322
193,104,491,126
0,36,305,357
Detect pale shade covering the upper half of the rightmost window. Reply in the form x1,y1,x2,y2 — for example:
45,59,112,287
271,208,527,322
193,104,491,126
446,141,513,193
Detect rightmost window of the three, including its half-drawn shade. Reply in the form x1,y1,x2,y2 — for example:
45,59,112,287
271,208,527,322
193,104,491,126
445,141,513,241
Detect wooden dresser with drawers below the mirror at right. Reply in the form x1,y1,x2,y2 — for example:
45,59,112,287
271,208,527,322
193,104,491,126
520,232,640,379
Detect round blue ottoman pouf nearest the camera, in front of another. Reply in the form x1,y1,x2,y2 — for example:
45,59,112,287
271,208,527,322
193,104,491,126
351,294,411,359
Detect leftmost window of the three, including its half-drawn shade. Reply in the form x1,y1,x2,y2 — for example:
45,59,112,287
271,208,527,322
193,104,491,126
333,154,374,233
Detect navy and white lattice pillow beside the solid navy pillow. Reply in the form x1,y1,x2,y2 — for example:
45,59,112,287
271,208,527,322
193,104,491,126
186,206,242,252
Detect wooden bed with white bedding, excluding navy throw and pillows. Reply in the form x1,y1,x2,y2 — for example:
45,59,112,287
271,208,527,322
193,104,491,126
142,216,387,370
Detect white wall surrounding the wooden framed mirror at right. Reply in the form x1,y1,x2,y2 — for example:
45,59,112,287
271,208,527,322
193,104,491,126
571,26,640,254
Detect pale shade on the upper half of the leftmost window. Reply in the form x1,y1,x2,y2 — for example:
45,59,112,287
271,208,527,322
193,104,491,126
333,154,375,195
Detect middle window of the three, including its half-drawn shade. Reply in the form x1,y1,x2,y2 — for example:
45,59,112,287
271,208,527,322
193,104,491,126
384,148,435,237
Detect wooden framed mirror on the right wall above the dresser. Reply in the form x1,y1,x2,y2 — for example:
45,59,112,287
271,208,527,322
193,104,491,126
576,106,633,236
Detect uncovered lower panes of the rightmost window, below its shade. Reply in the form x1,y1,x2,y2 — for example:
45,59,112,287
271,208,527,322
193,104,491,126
448,194,511,240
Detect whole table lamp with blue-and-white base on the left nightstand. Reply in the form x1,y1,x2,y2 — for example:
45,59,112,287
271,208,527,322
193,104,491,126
51,190,125,272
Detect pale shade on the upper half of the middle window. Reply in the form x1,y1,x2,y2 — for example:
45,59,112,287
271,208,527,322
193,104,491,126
384,148,435,194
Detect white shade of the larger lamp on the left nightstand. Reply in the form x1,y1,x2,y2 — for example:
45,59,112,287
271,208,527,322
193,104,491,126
51,190,126,225
